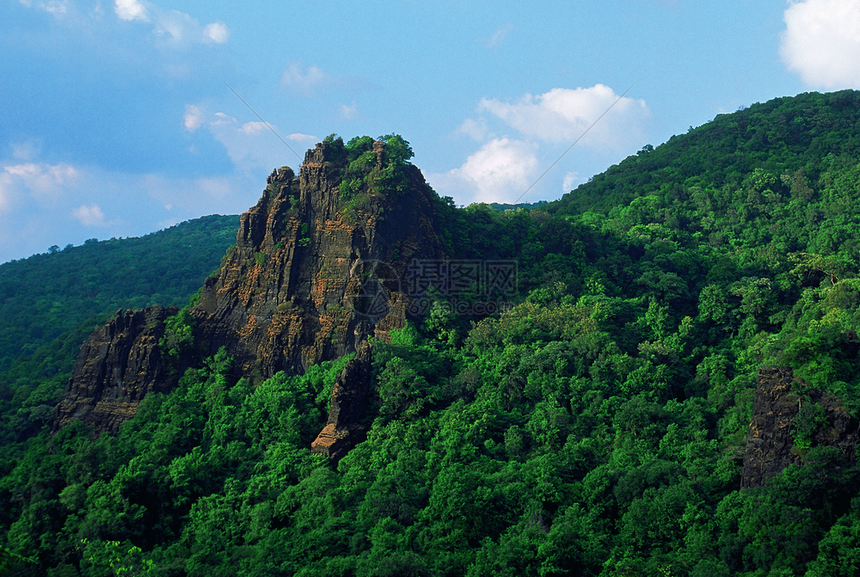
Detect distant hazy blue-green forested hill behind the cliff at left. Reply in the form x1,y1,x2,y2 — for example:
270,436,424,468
0,215,239,443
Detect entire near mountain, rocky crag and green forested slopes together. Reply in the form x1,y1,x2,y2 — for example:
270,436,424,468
5,92,860,577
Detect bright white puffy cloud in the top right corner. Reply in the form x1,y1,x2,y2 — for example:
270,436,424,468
780,0,860,89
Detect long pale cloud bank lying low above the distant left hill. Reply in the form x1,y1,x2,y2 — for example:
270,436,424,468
0,154,258,262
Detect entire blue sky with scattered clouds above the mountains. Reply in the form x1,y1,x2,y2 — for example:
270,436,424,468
0,0,860,262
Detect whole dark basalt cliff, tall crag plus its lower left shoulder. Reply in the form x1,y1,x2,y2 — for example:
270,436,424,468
54,141,445,431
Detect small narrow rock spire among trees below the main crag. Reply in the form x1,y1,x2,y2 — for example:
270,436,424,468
311,341,372,461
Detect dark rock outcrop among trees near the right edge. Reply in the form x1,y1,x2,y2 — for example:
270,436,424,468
741,367,860,489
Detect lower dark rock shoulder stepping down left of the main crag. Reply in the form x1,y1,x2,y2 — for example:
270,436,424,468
54,306,177,432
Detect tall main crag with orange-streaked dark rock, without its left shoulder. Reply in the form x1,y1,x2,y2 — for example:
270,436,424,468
192,142,444,380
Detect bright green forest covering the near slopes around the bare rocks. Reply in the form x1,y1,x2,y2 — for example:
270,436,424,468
5,91,860,577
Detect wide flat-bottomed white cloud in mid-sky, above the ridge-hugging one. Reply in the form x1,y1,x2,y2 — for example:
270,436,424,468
478,84,649,151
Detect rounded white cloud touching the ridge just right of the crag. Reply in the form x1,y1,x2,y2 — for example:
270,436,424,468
427,137,538,203
